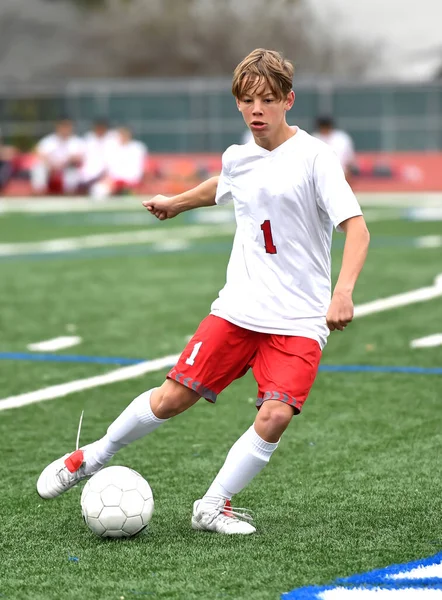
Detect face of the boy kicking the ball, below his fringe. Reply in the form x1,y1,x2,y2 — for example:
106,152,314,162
236,83,295,138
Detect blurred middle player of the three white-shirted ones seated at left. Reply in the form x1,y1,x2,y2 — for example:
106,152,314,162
80,119,118,195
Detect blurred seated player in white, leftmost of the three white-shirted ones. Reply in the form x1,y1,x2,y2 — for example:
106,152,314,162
31,118,83,194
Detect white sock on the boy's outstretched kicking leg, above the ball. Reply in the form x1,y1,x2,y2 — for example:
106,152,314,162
83,388,168,471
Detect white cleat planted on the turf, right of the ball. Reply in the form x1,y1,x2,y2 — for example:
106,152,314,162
192,500,256,535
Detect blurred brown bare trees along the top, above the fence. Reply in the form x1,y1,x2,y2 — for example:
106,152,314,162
0,0,373,81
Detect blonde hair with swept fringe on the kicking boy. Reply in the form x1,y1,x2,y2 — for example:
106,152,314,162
232,48,294,99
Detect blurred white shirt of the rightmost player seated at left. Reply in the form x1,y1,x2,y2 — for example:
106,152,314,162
108,140,147,184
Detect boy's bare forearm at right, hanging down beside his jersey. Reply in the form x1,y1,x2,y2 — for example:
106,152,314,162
334,217,370,294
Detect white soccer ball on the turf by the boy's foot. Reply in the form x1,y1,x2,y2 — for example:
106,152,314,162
81,467,154,538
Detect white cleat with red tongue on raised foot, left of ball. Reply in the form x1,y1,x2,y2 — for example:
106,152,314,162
37,449,97,499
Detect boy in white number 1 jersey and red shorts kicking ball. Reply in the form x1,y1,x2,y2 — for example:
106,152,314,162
37,49,369,534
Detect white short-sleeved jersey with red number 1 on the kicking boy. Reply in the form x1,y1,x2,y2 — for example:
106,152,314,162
211,129,362,348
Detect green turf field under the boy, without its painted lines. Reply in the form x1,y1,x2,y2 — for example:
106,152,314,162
0,196,442,600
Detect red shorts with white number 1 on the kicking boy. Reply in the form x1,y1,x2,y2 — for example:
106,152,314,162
167,315,321,413
